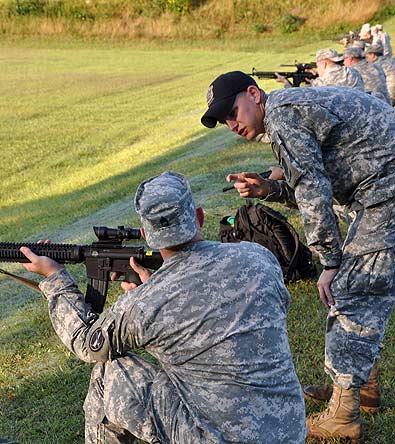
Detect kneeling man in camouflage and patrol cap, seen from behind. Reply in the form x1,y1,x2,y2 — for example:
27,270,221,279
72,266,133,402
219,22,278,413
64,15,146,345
21,172,306,444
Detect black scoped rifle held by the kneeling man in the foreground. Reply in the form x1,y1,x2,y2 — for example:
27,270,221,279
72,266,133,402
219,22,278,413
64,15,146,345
0,226,163,313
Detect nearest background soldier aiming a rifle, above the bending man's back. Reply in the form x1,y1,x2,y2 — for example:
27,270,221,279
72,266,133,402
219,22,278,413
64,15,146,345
277,48,364,91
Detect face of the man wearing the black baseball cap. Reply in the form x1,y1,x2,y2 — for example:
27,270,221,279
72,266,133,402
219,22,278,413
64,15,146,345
225,86,265,140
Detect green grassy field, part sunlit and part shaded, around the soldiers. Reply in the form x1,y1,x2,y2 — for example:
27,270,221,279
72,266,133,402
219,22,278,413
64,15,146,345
0,22,395,444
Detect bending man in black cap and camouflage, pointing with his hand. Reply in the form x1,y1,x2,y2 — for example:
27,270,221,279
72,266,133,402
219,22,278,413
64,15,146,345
201,71,395,442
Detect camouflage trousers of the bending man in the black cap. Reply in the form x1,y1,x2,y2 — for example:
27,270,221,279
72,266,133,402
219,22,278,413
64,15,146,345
325,201,395,389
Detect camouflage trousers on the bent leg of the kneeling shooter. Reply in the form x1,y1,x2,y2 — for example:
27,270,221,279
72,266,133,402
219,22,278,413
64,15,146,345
84,353,202,444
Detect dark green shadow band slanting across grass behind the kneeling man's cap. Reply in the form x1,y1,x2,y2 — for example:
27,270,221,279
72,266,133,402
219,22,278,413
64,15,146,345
0,125,249,242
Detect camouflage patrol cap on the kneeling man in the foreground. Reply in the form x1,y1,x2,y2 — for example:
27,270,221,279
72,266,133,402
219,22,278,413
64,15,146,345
134,171,198,249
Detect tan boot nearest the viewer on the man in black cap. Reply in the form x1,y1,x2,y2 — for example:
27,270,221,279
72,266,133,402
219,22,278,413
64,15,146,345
306,384,362,444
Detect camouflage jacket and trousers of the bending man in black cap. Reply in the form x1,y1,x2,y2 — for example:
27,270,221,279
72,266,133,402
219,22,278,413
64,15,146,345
264,88,395,389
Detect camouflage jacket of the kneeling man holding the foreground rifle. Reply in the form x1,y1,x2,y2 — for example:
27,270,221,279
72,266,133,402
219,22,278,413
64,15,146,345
40,241,305,444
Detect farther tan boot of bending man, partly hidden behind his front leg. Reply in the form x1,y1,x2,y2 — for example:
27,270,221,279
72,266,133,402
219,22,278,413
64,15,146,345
303,365,381,413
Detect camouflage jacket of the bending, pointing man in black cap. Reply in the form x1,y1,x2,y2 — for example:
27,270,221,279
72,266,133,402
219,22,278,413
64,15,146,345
264,87,395,266
